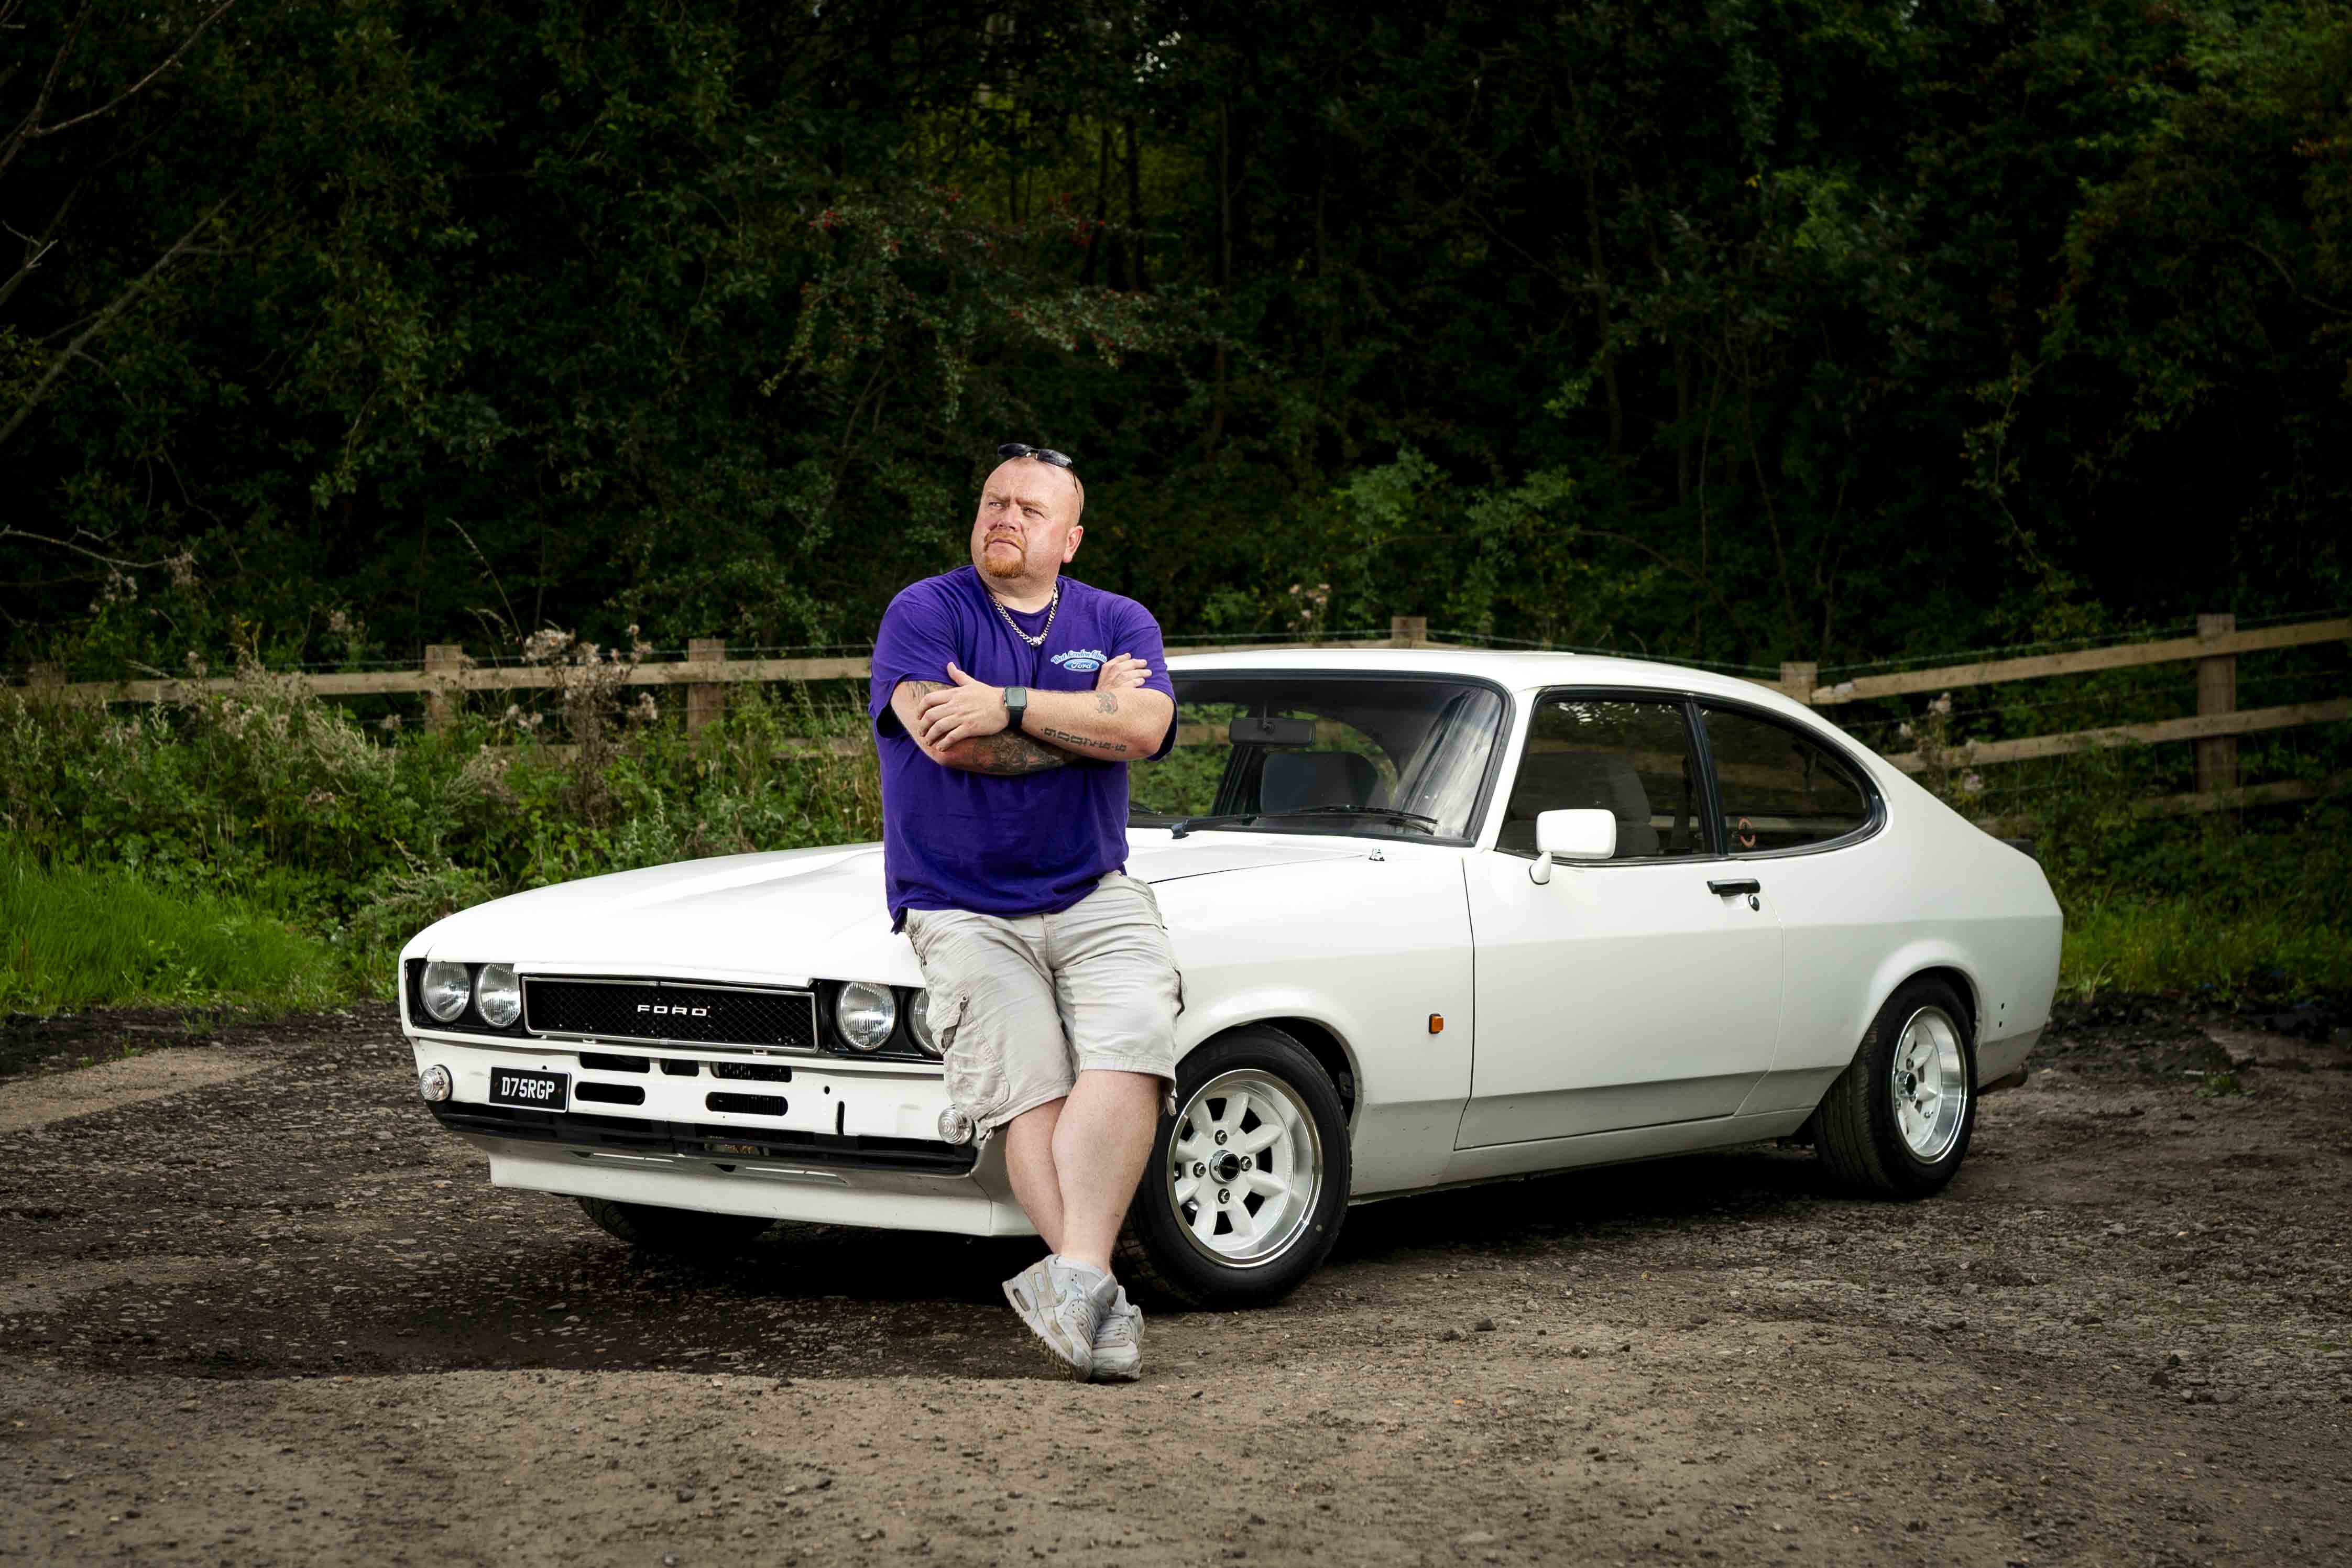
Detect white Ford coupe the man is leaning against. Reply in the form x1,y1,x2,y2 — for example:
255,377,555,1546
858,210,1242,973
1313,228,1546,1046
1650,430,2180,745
402,649,2060,1304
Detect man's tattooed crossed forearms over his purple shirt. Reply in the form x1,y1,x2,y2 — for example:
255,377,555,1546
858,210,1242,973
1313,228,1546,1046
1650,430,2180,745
889,653,1176,776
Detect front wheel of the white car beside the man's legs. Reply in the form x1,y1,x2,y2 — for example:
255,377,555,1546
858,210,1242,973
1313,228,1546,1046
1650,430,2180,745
1120,1025,1350,1307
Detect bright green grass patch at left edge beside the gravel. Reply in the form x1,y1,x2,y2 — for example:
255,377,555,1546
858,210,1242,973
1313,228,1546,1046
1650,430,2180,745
0,853,362,1013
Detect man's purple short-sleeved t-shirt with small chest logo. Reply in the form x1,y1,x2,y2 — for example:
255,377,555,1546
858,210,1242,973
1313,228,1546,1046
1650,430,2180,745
868,566,1176,926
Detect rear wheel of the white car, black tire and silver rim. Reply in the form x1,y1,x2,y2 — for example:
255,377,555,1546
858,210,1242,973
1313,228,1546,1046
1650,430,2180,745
1813,980,1976,1199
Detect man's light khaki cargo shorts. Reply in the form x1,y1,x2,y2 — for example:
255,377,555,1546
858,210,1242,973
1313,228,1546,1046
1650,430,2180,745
905,872,1183,1140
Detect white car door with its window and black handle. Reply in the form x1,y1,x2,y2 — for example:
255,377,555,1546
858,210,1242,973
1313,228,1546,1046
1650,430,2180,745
1456,689,1780,1149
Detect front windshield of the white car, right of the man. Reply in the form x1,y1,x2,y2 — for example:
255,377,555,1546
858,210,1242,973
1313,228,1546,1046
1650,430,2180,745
1126,675,1503,839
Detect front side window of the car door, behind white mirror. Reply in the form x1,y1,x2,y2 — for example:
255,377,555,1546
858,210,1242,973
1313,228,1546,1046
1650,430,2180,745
1496,691,1708,860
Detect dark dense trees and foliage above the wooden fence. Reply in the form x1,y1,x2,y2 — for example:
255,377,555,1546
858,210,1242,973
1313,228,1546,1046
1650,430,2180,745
0,0,2352,677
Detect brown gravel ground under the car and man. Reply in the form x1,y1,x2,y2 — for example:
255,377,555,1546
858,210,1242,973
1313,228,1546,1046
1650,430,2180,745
0,999,2352,1566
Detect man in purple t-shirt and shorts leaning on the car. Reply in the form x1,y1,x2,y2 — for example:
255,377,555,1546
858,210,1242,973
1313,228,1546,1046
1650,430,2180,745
870,444,1178,1380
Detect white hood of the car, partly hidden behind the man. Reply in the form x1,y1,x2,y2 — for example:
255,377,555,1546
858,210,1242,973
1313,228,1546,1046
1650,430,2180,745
402,830,1369,985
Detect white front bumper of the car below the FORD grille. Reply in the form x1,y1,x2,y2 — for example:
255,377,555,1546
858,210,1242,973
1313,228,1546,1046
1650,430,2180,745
409,1032,1030,1236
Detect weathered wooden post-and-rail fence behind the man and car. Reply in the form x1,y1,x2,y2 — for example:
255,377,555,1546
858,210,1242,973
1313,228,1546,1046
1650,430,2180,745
33,613,2352,816
